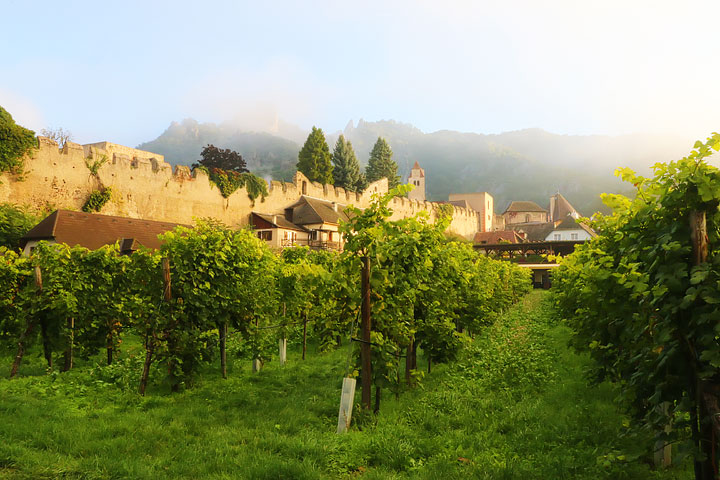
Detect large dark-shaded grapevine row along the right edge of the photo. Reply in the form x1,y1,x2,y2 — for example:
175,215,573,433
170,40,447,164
553,134,720,459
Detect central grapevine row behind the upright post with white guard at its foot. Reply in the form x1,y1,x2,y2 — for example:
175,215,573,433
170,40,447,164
341,185,531,404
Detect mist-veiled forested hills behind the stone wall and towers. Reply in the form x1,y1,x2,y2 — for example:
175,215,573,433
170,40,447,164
138,119,692,215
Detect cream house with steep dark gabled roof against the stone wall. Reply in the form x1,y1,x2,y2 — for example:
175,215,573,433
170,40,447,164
251,195,348,250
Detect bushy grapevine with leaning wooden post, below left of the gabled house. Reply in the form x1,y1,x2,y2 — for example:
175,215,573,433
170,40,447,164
155,222,276,382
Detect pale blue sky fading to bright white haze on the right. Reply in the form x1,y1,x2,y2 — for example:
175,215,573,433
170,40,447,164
0,0,720,145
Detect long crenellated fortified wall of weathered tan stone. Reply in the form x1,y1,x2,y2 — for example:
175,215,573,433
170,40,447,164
0,137,479,238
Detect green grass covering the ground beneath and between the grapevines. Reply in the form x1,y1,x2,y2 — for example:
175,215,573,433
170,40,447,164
0,292,692,479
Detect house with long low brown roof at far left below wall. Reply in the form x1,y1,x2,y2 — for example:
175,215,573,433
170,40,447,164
20,210,186,255
